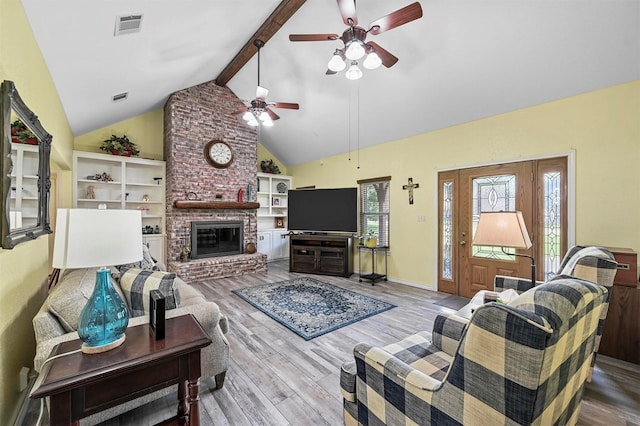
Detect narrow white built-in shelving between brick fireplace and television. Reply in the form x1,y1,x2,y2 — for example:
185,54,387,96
256,173,293,261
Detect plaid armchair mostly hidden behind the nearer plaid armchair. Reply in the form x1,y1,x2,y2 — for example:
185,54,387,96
494,246,618,382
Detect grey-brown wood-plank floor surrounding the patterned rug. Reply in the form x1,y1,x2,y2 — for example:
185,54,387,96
25,262,640,426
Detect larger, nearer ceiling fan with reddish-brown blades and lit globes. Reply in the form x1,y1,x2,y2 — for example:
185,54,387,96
289,0,422,80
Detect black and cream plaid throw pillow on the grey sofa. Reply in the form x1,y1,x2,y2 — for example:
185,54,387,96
120,268,180,318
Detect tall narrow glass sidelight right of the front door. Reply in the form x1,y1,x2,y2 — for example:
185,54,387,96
542,172,562,281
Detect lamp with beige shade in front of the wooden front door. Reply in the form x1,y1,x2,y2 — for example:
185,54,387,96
472,211,536,285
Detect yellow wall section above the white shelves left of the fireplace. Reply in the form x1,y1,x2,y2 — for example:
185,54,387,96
73,108,164,160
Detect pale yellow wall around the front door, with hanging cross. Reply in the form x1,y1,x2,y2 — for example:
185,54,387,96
289,81,640,288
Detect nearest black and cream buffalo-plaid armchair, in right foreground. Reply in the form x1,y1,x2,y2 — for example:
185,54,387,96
340,277,607,426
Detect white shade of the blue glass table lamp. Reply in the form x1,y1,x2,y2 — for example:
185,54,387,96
53,209,142,269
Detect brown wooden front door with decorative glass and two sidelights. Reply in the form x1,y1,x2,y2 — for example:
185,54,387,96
438,157,567,297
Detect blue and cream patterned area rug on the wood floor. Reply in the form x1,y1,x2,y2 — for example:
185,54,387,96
233,277,395,340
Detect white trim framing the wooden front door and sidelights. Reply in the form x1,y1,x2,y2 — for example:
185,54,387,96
433,149,576,291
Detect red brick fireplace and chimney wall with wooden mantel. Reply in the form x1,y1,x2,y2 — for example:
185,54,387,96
164,82,267,282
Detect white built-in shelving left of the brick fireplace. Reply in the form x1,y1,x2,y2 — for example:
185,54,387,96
73,151,166,262
